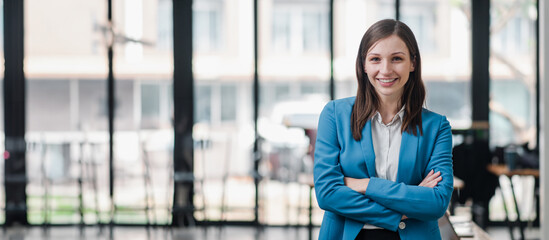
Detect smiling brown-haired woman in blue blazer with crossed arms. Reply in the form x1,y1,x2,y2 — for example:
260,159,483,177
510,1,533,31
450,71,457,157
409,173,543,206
314,20,453,240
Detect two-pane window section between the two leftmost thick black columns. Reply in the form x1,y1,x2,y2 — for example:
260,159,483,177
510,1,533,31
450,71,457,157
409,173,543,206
25,0,173,224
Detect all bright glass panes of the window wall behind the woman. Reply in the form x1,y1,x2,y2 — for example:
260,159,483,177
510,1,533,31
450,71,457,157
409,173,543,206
8,0,537,228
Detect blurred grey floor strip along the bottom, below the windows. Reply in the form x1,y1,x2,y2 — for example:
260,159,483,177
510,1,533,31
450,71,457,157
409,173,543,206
0,226,540,240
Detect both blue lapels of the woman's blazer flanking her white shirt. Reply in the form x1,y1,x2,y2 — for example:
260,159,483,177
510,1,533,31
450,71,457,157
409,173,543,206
360,120,419,183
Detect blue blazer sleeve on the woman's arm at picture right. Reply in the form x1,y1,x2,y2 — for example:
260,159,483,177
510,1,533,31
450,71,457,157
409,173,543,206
365,117,454,221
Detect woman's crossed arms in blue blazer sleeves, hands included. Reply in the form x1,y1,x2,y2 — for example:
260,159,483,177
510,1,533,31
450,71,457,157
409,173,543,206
314,102,453,231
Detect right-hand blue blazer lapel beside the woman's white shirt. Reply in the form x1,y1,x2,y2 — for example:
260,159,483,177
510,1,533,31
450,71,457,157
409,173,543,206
397,129,419,183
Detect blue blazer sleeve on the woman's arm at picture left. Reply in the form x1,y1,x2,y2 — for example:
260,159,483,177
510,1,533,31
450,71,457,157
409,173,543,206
314,101,402,231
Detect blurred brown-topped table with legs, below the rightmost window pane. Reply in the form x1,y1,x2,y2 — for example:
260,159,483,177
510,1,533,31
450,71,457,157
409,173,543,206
486,164,539,240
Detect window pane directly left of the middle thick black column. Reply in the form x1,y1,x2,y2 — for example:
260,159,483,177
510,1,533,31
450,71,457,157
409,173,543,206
113,0,173,224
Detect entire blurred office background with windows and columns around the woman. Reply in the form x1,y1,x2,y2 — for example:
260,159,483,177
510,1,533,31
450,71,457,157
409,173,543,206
0,0,549,239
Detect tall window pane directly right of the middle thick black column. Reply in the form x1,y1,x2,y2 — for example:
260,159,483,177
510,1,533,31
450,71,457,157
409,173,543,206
193,0,255,221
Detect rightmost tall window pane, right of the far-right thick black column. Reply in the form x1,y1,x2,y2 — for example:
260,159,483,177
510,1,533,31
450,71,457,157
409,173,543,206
490,0,537,149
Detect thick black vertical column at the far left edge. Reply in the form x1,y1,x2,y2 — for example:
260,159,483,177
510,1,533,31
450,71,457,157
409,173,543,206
4,0,28,226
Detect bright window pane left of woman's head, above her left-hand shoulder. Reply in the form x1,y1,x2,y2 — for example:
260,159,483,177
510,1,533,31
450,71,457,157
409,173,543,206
334,0,394,98
